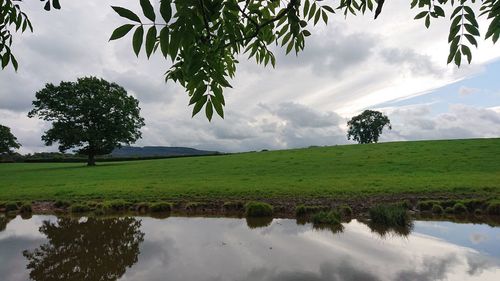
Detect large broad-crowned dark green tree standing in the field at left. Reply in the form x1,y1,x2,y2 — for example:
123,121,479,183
28,77,144,166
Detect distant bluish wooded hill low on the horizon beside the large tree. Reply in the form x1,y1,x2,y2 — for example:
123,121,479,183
111,146,220,157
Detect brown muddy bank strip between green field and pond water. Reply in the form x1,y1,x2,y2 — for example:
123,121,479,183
0,191,496,218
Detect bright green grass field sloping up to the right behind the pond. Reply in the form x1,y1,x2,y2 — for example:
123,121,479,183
0,139,500,201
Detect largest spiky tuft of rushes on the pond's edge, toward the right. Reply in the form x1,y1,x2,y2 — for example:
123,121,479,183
370,202,410,227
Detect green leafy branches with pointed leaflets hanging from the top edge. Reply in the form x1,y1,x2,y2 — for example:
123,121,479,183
0,0,500,120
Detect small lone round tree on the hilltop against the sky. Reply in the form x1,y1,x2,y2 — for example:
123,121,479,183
347,110,392,143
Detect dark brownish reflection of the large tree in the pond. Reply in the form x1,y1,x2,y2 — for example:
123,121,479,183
23,218,144,281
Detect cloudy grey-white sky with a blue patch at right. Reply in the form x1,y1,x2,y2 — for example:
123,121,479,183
0,0,500,153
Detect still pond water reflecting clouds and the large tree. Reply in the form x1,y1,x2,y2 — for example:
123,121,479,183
0,216,500,281
